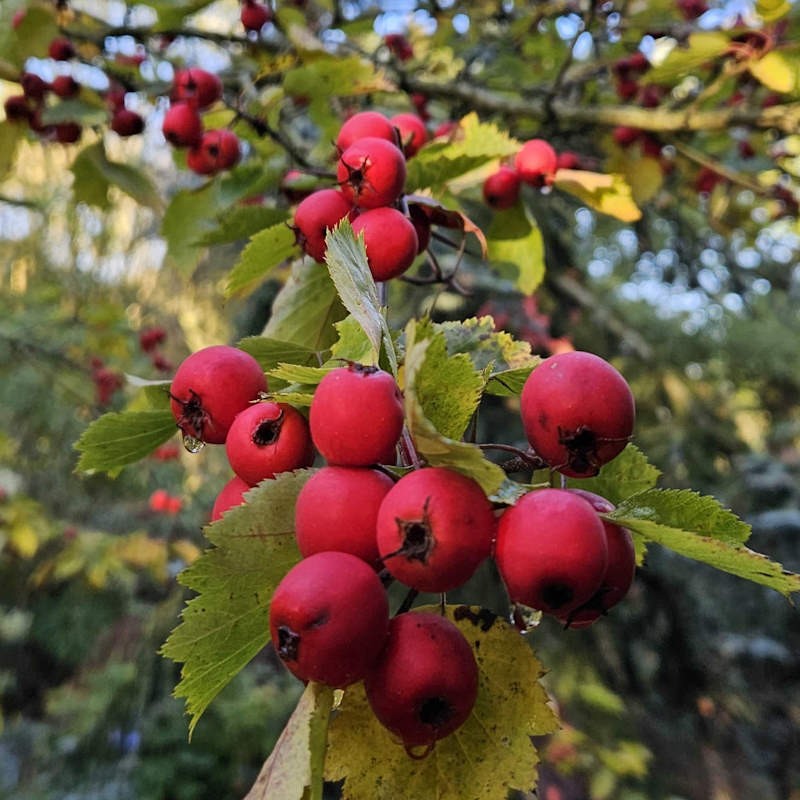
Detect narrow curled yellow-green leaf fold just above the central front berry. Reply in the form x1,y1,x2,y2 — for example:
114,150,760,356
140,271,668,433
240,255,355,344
403,320,506,495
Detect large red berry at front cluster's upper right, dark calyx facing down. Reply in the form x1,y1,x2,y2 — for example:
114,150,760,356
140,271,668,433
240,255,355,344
520,351,636,478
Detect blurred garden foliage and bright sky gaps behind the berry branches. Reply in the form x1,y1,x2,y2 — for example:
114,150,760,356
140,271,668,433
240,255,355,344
0,2,800,800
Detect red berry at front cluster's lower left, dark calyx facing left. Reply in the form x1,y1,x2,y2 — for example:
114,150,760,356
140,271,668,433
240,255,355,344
269,551,389,688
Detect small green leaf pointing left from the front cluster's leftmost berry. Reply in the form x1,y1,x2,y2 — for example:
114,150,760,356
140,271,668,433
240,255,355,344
75,410,175,472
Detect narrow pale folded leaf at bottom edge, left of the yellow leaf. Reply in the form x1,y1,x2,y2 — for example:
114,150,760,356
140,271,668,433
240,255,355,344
244,682,333,800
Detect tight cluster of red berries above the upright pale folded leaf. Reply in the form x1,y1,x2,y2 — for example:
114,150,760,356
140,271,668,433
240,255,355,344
294,111,430,281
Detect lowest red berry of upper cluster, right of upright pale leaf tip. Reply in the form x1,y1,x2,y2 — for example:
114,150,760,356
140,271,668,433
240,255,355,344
353,207,419,281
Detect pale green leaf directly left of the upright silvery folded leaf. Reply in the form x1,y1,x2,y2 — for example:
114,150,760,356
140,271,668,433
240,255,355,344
263,261,347,351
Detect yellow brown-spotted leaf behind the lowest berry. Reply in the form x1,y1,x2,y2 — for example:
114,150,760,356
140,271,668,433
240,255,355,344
325,606,556,800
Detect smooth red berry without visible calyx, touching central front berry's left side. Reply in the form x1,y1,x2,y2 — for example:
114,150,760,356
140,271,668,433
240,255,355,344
294,467,394,568
